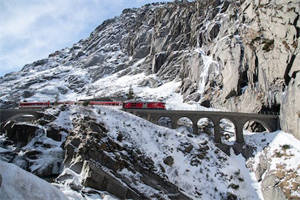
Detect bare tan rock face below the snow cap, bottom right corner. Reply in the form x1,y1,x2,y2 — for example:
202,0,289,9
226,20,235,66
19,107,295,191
248,145,300,200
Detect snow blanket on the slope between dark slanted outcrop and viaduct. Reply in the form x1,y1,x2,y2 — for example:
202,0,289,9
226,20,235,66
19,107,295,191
58,107,258,199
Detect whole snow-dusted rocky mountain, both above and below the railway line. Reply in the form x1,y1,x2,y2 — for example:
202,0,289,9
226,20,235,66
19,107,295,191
0,0,300,199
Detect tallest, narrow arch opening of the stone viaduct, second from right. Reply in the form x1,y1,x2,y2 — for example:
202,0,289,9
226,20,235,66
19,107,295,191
219,118,237,145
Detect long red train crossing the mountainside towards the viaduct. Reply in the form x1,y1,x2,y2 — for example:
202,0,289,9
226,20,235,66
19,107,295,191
19,101,166,110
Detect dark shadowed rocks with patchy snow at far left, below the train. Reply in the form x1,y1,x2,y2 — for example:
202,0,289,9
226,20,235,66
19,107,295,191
0,121,64,178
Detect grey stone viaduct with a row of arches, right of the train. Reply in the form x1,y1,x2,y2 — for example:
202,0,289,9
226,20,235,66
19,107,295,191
125,109,280,144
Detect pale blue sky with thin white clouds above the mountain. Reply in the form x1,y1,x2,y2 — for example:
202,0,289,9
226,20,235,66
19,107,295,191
0,0,172,76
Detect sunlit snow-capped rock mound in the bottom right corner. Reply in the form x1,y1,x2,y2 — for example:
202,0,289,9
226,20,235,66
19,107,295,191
245,131,300,199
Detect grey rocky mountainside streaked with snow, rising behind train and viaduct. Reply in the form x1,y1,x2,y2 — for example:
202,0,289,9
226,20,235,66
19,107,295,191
0,0,300,138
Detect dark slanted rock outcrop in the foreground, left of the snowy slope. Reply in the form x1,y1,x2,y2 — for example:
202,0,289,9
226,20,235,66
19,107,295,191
61,117,189,199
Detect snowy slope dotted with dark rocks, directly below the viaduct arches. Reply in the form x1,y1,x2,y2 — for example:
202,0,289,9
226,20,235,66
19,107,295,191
95,105,258,199
